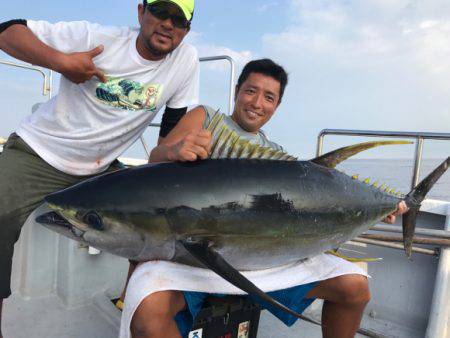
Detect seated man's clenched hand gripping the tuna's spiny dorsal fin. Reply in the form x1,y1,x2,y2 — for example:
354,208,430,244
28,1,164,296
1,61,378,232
168,129,211,162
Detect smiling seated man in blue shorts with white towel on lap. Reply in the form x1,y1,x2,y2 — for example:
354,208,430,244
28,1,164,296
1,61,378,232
121,59,404,338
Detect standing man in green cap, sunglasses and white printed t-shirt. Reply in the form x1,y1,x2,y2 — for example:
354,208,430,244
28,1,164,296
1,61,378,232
0,0,199,338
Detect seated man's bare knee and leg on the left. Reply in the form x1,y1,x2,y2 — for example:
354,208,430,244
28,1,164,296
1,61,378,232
130,291,186,338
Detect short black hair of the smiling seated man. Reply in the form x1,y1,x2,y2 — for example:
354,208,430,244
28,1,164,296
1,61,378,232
237,59,288,103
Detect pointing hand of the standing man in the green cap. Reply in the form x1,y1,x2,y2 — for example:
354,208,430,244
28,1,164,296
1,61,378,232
58,45,107,84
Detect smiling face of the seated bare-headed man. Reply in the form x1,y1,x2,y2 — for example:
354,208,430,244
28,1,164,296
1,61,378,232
232,73,280,133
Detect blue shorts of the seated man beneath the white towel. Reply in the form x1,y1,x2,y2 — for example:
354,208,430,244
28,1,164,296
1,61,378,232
175,282,319,337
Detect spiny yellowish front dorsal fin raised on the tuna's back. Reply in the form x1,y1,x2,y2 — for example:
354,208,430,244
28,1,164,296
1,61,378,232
206,111,297,161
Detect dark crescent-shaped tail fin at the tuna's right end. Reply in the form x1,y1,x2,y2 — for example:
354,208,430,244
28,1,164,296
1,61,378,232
402,157,450,257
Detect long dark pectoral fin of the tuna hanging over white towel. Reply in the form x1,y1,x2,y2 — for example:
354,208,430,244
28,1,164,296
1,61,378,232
181,239,321,325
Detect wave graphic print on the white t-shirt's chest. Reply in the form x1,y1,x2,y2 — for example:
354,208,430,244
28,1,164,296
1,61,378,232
95,78,163,112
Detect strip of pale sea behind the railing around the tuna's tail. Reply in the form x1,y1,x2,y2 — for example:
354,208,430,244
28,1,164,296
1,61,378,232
337,159,450,202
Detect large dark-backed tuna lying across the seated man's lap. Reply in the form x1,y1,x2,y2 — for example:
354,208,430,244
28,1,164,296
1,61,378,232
38,142,450,315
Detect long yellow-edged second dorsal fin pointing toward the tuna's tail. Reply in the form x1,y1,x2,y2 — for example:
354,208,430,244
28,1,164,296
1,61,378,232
310,141,412,168
